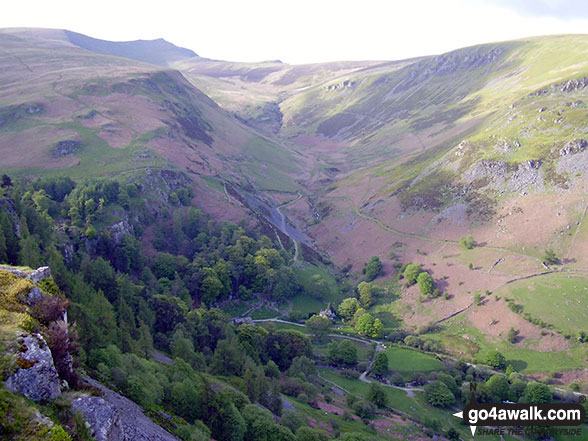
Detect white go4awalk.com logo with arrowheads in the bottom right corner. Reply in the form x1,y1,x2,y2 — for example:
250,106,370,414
453,385,586,436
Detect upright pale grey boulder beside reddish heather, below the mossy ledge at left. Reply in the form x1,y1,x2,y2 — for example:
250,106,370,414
6,334,61,402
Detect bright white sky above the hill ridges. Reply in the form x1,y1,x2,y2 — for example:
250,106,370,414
0,0,588,64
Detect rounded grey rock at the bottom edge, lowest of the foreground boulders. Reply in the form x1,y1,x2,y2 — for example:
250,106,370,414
71,397,125,441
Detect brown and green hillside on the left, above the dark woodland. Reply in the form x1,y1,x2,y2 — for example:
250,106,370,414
0,34,298,195
